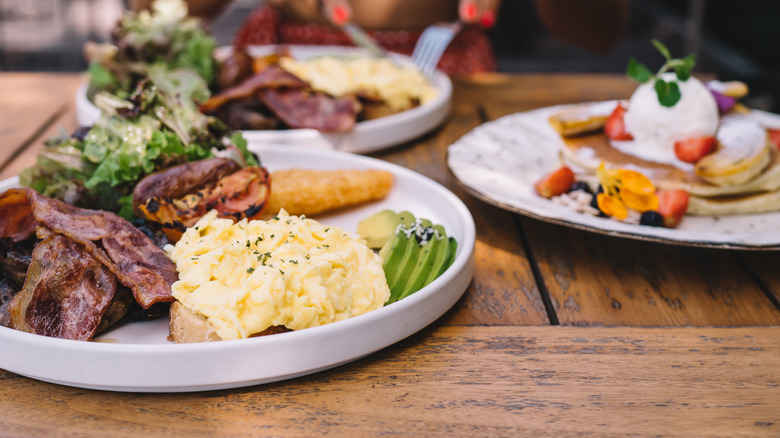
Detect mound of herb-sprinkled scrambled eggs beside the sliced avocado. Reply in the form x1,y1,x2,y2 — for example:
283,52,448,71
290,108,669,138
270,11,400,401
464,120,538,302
166,210,390,339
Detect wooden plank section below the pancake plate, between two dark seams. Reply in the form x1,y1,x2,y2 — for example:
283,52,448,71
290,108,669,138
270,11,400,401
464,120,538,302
522,219,780,325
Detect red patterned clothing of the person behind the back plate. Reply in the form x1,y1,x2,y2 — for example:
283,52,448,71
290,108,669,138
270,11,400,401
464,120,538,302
233,6,496,75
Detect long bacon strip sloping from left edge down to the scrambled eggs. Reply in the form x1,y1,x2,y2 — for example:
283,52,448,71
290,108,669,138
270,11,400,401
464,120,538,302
0,188,178,309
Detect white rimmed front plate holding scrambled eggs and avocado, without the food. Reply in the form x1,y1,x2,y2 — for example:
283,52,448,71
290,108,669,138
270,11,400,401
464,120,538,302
0,146,475,392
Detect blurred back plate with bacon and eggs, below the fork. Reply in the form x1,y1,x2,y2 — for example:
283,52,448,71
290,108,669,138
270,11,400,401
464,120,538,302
76,46,452,153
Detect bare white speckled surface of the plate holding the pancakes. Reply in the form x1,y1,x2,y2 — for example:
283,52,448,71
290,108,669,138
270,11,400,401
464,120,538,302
447,107,780,249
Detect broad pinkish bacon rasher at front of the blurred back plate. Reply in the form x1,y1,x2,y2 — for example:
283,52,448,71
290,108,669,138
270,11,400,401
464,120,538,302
257,88,360,132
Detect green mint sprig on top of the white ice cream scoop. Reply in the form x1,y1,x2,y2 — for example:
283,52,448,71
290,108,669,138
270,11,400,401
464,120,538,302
626,39,696,107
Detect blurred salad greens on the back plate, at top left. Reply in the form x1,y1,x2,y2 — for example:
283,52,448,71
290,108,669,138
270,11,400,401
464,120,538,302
85,0,217,100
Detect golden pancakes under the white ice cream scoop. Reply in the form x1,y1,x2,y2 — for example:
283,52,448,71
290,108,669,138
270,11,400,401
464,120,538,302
549,98,780,216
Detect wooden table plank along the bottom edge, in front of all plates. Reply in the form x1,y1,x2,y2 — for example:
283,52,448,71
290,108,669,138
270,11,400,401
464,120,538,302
0,326,780,437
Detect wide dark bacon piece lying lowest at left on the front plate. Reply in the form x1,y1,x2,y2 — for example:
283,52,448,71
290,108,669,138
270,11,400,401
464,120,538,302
9,234,117,341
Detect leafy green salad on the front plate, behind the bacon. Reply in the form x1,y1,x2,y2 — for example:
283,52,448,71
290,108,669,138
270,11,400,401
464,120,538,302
20,72,258,218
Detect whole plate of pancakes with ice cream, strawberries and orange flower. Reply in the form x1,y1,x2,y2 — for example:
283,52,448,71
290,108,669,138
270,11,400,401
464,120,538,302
448,40,780,249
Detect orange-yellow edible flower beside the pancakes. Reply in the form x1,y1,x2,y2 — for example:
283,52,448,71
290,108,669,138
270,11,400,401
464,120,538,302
596,162,658,220
